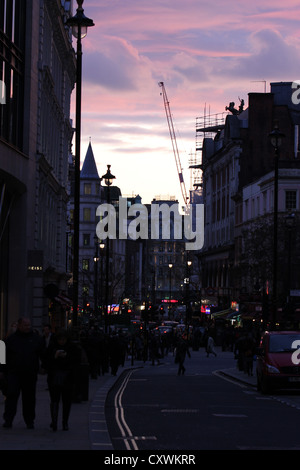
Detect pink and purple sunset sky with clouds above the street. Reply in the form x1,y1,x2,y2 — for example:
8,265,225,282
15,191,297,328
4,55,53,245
71,0,300,204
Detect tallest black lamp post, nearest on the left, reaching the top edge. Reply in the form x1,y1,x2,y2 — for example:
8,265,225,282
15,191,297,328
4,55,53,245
66,0,94,327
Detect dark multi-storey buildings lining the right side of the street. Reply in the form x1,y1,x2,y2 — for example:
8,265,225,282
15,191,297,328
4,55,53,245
199,83,300,320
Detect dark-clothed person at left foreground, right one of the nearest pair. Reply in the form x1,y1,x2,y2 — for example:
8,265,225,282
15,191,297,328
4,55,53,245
44,329,81,431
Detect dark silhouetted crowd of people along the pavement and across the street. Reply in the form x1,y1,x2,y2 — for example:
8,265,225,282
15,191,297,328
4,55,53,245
0,317,257,431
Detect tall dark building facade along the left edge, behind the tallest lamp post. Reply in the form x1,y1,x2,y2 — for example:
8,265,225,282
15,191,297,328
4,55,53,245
0,0,76,335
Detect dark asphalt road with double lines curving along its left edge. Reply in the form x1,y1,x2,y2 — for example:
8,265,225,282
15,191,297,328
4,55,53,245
106,349,300,451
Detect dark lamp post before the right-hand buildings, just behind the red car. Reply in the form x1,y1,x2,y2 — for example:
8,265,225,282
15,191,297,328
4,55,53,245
269,120,284,327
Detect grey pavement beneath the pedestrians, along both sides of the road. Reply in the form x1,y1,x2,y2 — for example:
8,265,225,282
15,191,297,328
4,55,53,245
0,348,256,451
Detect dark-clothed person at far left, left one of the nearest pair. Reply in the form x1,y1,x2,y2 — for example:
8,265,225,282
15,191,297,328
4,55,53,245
3,317,43,429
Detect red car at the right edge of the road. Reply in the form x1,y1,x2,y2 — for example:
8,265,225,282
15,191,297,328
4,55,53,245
256,331,300,394
